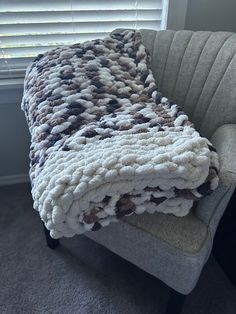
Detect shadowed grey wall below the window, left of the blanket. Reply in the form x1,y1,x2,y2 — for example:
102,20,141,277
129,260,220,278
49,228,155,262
0,88,30,179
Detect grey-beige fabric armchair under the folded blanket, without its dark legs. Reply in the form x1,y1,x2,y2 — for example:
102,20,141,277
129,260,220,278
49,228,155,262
86,30,236,294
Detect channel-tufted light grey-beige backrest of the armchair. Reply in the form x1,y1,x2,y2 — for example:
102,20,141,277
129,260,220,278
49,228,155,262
141,29,236,137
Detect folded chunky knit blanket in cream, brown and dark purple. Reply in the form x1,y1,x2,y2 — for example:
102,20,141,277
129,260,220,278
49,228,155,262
22,31,219,238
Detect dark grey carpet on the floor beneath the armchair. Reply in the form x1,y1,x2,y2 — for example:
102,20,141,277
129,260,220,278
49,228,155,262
0,184,236,314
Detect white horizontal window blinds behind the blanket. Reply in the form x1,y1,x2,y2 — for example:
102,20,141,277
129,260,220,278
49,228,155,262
0,0,168,77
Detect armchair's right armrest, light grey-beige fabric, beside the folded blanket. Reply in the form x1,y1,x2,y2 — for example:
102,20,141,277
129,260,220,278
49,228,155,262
195,124,236,236
